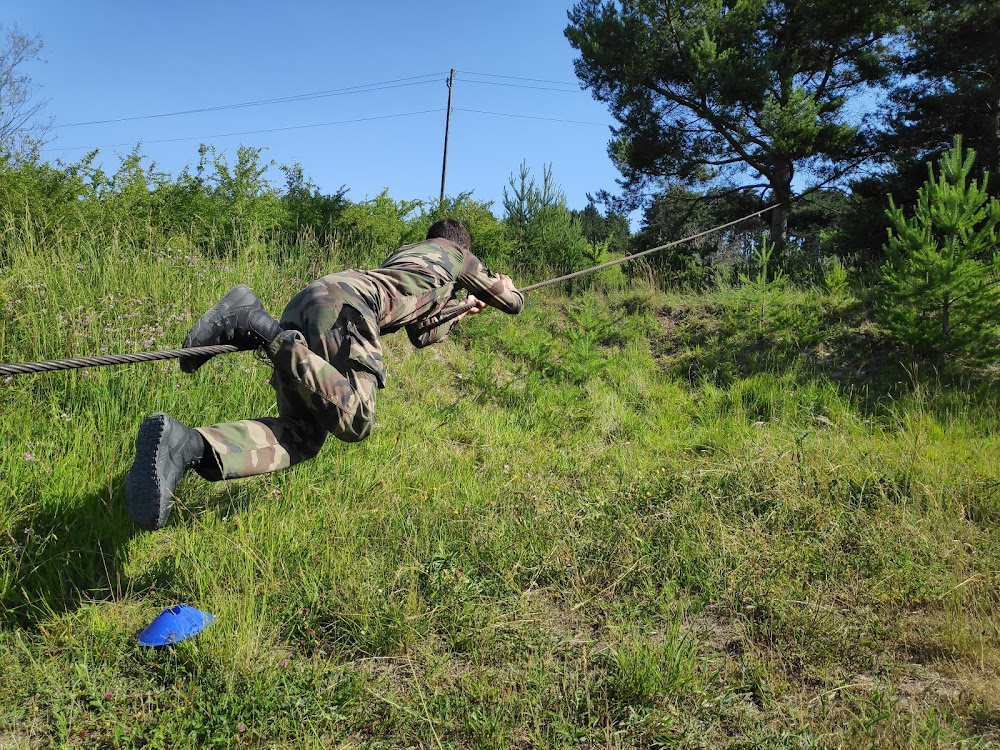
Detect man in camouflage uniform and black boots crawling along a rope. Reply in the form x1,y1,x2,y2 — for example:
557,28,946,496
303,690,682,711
125,219,524,530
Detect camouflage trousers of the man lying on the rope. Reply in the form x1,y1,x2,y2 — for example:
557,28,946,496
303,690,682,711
196,282,379,480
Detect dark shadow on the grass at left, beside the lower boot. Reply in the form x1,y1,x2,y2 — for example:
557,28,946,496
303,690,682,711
0,472,139,627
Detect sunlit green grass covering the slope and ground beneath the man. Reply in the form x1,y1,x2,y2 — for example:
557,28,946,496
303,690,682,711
0,232,1000,748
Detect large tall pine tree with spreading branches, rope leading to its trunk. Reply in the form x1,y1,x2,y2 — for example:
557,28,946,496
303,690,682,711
566,0,909,254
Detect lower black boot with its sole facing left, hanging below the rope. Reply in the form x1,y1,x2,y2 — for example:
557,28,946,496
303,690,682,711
125,414,205,531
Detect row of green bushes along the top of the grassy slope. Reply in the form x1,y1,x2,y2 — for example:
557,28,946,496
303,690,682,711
0,144,612,286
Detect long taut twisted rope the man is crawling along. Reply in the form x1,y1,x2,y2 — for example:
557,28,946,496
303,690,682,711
0,204,778,376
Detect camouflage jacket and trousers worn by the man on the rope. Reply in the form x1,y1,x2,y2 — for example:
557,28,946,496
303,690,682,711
197,239,524,480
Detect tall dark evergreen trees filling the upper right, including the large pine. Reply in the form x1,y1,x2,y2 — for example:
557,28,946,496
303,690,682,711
566,0,1000,274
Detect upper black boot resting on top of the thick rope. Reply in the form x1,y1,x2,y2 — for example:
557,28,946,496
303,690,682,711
181,284,281,372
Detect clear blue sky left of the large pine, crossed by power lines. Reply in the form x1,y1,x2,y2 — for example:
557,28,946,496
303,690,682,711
9,0,617,213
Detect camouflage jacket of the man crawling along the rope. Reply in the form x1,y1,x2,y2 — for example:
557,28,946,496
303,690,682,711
283,239,524,388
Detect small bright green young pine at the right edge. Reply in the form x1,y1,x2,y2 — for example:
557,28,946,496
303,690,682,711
882,136,1000,364
